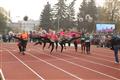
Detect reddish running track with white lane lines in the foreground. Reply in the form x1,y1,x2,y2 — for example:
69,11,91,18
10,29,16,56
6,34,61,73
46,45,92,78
0,43,120,80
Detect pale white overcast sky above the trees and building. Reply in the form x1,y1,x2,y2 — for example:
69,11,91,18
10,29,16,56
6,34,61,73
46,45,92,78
0,0,103,21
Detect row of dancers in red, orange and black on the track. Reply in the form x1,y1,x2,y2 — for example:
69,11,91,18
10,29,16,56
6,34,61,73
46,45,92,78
14,29,90,55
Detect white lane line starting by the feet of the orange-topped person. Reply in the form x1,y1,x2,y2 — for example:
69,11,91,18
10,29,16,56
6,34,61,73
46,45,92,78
26,52,83,80
